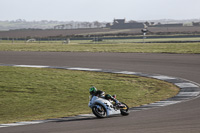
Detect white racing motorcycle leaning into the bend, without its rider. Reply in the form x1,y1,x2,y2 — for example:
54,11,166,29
88,96,129,118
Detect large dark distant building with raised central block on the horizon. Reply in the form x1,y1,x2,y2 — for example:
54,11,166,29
106,19,144,29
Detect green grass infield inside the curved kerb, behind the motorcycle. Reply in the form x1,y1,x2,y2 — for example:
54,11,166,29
0,66,179,123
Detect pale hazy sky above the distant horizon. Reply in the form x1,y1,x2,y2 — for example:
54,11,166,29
0,0,200,22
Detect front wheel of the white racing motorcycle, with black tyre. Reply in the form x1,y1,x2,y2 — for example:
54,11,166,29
92,104,107,118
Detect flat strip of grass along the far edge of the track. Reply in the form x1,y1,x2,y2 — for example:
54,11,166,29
0,41,200,54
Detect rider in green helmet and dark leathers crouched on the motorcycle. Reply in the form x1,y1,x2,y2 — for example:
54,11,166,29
89,86,124,108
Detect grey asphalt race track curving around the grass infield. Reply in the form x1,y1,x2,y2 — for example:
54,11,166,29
0,52,200,133
